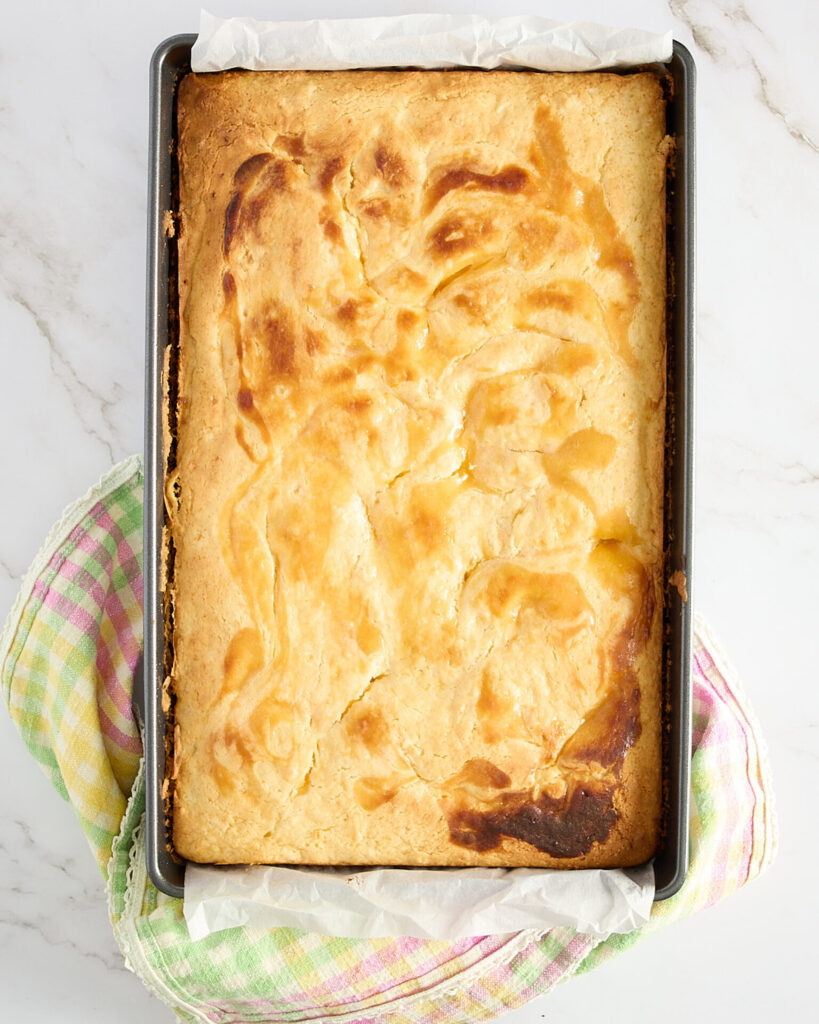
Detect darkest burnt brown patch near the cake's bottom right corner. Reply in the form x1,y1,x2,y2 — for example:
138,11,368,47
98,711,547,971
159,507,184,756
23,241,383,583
446,785,617,857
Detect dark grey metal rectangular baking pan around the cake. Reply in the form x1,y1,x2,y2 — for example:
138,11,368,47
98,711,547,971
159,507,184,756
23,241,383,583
140,35,695,900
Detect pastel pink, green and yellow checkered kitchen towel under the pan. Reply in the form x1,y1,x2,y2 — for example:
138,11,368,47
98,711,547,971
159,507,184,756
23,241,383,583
0,458,776,1024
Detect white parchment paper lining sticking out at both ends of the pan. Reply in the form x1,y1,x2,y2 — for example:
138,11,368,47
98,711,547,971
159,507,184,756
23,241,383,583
184,10,672,939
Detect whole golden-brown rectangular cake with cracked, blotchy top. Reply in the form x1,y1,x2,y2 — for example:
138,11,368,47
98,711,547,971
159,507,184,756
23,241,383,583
166,71,669,866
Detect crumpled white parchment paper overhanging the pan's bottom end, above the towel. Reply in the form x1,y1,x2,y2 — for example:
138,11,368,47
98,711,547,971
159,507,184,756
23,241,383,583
184,864,654,939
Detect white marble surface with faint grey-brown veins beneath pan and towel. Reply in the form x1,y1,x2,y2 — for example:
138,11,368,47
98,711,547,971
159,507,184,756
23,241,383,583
0,0,819,1024
